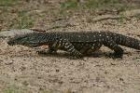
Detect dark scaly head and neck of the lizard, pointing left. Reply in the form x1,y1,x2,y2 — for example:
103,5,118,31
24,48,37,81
7,32,55,47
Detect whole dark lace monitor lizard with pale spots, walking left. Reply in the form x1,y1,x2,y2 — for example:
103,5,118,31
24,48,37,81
8,31,140,58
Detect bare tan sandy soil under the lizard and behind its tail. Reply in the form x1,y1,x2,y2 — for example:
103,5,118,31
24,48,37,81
0,20,140,93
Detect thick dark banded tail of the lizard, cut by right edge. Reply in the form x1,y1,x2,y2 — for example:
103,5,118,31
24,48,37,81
113,34,140,50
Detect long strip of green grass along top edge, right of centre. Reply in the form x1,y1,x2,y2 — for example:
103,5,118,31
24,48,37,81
60,0,136,12
